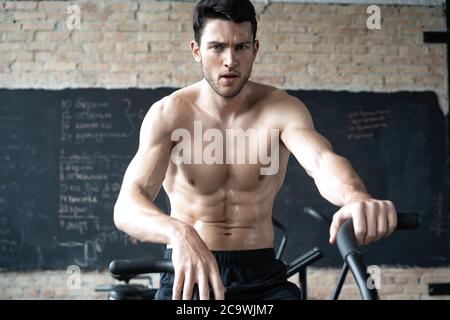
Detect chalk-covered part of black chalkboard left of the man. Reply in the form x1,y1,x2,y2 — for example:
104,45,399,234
0,89,174,270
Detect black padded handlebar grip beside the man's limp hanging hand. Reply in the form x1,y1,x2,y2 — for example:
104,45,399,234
109,259,174,277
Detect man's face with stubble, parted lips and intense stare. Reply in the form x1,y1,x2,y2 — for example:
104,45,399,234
191,19,259,98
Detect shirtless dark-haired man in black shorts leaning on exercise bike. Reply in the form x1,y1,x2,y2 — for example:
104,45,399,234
114,0,397,299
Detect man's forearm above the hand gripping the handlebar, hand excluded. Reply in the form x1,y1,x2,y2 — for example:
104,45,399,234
313,152,371,207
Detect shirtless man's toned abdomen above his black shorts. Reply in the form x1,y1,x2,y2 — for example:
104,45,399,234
168,184,274,251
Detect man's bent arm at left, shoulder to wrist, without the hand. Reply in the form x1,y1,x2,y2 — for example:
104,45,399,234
114,97,182,244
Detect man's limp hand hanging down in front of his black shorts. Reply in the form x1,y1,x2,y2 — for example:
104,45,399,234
172,225,225,300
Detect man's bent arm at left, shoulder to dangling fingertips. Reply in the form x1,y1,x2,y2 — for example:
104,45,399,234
114,99,224,300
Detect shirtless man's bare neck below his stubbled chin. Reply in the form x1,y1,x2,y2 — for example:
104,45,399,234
199,79,253,123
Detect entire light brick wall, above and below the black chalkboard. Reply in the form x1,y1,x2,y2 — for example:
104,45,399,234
0,0,450,299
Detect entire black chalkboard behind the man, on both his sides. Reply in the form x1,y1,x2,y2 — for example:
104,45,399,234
0,88,450,270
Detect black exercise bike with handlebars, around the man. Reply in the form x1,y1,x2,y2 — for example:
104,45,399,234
96,207,420,300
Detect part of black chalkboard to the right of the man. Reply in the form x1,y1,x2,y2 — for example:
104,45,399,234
280,91,450,266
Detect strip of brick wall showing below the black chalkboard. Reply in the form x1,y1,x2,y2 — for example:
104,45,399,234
0,267,450,300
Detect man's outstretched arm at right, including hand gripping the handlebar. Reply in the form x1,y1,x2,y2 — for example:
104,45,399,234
280,96,397,245
